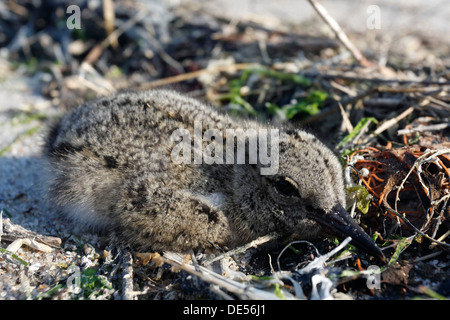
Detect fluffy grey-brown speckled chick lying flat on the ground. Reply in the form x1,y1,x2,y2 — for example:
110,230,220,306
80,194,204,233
45,90,382,257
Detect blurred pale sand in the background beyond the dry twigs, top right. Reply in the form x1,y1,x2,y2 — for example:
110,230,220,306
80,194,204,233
184,0,450,43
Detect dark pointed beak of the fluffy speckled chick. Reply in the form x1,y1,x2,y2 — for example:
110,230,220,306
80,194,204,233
309,205,386,263
